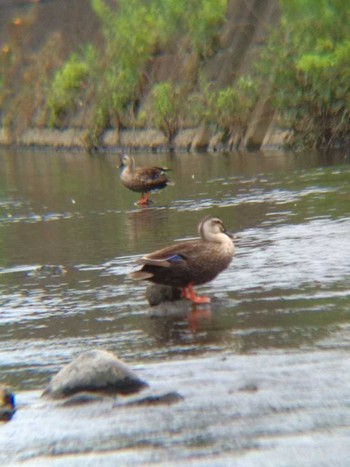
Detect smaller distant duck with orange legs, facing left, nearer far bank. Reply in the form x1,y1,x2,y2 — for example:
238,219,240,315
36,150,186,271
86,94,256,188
119,155,173,206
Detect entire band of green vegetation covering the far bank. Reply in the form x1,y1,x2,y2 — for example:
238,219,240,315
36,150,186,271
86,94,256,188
0,0,350,149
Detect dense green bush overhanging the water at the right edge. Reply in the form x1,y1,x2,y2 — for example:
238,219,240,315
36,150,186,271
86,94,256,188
259,0,350,147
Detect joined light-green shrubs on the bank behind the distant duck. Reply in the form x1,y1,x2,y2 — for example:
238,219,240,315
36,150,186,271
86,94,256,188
39,0,226,149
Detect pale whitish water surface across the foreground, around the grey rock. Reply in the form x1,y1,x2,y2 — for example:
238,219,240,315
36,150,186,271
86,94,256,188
0,352,350,466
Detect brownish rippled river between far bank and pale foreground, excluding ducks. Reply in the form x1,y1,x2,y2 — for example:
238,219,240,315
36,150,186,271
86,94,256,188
0,149,350,465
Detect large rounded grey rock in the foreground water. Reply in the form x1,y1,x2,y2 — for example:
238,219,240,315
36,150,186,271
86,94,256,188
42,350,148,399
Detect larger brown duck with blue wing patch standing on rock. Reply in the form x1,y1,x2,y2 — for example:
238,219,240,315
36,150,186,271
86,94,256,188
130,216,234,304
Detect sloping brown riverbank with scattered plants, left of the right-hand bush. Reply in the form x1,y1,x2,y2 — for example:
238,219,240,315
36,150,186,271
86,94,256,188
0,0,288,151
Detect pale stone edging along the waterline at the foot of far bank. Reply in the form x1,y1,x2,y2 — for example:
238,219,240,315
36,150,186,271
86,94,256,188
0,123,290,152
